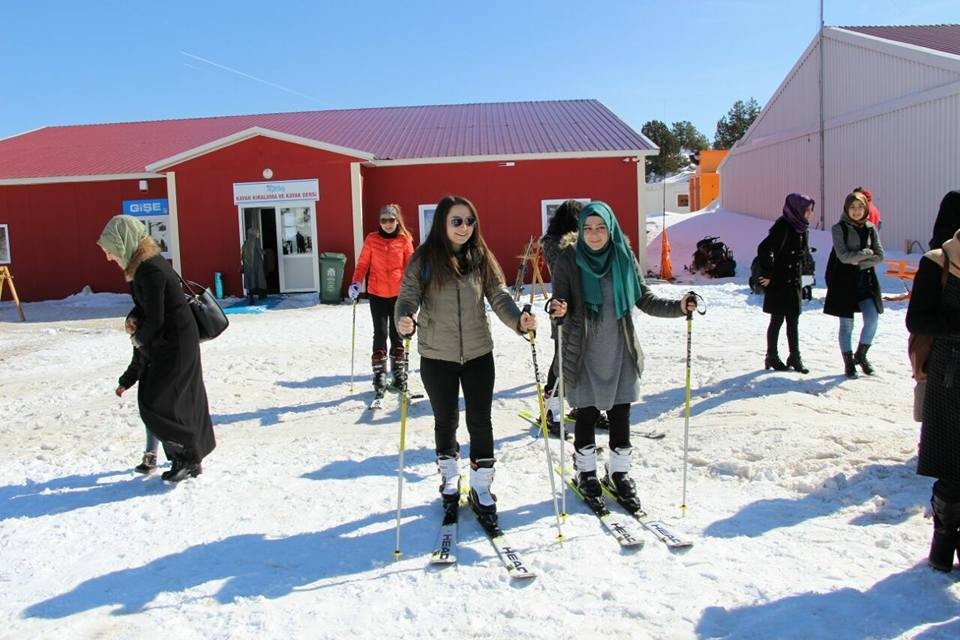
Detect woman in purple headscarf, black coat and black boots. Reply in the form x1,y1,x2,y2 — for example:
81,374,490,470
757,193,816,373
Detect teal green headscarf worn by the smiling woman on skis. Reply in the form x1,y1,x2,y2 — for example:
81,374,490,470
577,202,640,320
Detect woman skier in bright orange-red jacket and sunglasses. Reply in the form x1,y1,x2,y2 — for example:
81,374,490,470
347,204,413,398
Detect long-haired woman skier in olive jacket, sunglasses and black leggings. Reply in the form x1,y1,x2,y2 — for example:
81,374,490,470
394,196,537,530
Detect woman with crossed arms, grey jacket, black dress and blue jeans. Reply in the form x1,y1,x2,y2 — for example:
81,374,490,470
823,191,883,378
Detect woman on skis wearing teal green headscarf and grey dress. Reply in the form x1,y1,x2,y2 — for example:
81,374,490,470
551,202,696,510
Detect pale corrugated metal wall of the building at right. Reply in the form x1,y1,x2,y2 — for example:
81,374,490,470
719,25,960,250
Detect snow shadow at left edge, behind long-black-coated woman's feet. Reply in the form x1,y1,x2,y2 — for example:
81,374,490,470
0,469,169,520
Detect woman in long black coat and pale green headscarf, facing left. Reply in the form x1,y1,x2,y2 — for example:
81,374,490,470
97,216,216,482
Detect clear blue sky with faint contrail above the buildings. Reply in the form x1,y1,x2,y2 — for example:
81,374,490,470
0,0,960,140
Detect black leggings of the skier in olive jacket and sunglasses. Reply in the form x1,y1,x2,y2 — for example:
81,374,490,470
420,352,495,461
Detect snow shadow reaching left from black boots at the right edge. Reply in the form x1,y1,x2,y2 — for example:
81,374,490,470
703,458,930,538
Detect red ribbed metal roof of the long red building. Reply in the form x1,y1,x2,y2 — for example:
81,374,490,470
0,100,656,180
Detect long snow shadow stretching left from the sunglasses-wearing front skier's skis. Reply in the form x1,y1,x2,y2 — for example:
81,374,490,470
22,503,551,619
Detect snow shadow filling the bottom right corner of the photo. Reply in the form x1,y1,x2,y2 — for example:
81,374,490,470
696,563,960,640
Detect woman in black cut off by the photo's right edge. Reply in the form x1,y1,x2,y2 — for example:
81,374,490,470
907,231,960,571
